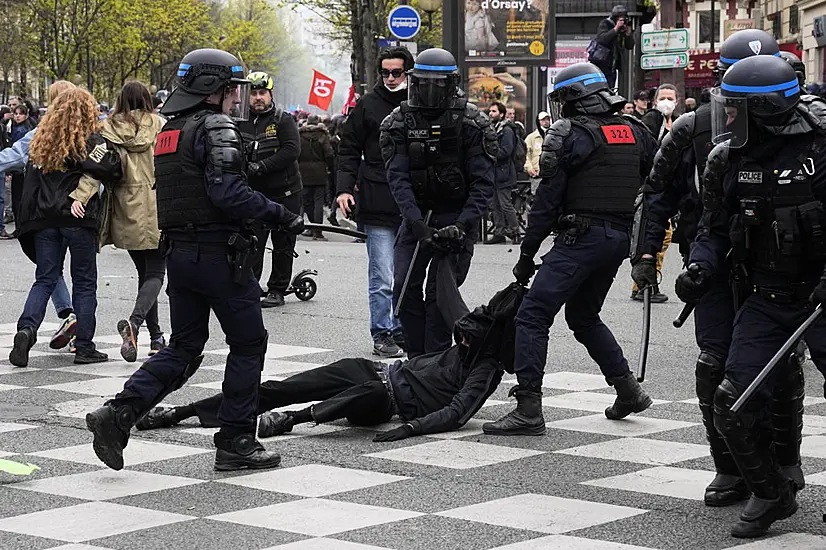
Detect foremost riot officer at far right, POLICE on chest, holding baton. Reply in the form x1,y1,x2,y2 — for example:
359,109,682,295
676,55,826,538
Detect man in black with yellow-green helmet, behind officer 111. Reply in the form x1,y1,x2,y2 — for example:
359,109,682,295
238,71,302,308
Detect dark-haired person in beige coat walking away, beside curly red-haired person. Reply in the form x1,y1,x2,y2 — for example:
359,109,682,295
78,81,166,363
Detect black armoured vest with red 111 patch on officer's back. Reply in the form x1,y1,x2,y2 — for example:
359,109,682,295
155,111,233,230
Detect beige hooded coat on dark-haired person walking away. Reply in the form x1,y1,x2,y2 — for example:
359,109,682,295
89,112,163,250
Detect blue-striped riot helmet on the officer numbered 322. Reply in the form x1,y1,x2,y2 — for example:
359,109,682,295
548,63,625,121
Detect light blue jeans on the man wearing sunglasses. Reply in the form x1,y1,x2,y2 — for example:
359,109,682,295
364,225,401,338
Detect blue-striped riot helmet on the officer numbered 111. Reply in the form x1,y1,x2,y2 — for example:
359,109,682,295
161,48,249,119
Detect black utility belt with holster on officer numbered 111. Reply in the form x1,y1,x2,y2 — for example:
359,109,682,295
158,232,258,285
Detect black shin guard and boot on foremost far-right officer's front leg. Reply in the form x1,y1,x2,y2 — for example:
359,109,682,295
714,380,797,538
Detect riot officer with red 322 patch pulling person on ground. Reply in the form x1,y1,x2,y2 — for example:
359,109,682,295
482,63,657,435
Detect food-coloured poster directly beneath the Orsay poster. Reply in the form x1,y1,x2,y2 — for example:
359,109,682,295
467,66,530,124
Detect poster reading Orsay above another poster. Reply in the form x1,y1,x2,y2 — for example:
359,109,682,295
461,0,555,65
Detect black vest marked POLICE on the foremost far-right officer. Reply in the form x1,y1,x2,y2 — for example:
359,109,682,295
731,134,826,285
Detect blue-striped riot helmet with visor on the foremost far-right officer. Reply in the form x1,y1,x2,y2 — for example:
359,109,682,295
711,55,800,148
